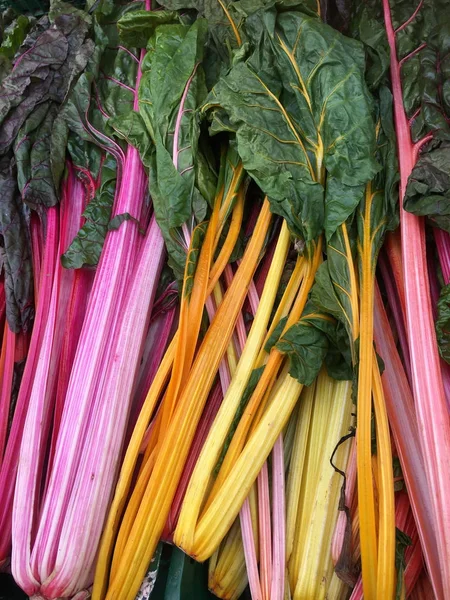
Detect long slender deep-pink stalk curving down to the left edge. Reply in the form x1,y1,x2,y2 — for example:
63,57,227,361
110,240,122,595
0,207,58,566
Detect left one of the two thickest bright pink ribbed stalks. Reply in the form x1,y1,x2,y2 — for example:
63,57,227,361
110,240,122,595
32,147,147,583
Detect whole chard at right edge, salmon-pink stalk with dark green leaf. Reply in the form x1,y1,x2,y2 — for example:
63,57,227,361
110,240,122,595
383,0,450,598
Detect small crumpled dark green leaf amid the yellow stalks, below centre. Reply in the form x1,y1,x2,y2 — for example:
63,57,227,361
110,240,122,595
276,301,335,385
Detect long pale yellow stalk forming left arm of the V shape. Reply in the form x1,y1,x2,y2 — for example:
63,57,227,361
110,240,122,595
175,219,290,547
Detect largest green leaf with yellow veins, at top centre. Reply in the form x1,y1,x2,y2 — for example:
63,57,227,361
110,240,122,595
205,10,379,241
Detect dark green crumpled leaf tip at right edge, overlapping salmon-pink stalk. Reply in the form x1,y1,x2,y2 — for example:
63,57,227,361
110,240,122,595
403,142,450,233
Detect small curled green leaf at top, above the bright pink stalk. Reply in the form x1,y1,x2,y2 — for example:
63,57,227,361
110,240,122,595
117,10,178,48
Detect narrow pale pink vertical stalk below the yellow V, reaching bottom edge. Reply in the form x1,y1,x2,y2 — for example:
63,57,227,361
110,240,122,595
269,434,286,600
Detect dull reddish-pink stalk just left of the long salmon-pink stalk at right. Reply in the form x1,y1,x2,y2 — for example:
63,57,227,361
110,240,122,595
374,288,444,598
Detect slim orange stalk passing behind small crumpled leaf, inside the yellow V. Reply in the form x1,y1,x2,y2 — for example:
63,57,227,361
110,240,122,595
210,239,322,498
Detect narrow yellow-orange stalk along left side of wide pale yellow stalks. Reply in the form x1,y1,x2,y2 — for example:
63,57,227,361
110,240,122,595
286,382,316,562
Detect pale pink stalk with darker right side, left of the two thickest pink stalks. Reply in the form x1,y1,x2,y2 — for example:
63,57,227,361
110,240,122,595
12,165,84,595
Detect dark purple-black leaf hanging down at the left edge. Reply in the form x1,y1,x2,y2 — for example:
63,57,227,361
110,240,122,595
0,156,34,333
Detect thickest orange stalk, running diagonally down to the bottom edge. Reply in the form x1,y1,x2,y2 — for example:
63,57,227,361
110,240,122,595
102,199,271,600
